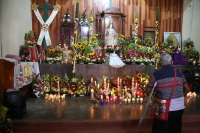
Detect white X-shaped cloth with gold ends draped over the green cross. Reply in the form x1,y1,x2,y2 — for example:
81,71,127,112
31,3,61,46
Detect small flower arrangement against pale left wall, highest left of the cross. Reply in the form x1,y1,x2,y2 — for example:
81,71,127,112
24,30,36,46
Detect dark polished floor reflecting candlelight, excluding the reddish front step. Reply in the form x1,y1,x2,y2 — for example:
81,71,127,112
14,94,200,121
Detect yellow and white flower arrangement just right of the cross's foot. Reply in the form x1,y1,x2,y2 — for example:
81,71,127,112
46,46,63,63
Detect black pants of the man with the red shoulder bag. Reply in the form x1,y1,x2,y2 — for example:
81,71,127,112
152,109,184,133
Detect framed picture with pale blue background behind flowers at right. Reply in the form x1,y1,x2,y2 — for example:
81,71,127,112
164,32,182,48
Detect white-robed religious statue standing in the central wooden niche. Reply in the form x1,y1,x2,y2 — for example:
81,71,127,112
105,19,119,47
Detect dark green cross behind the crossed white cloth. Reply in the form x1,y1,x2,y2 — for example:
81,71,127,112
38,0,54,50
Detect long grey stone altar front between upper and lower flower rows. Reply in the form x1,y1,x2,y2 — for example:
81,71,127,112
39,63,155,81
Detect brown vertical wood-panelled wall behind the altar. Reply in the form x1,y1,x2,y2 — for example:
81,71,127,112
32,0,183,46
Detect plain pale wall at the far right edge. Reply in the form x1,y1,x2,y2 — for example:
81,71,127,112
182,0,200,52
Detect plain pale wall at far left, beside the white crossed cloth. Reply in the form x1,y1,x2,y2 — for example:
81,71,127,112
0,0,32,56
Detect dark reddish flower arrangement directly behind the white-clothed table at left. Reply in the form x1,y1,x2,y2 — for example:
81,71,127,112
19,45,31,61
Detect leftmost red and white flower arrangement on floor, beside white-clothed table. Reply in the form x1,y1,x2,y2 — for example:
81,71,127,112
32,74,51,97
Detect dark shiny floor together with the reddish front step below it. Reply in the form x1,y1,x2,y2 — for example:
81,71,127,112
10,95,200,133
